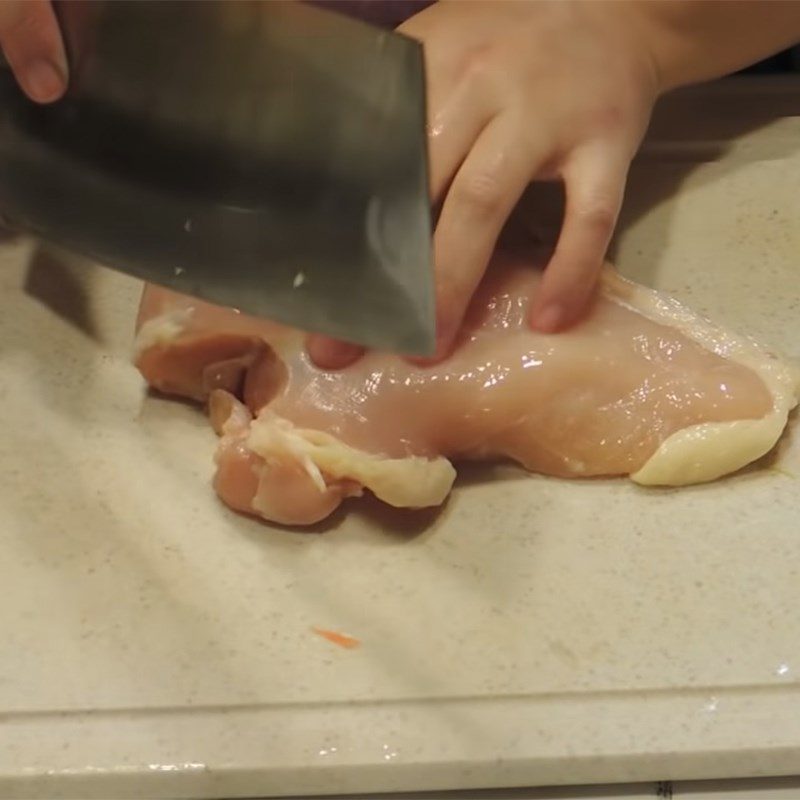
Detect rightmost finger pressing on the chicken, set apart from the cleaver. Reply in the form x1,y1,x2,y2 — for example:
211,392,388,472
530,146,629,333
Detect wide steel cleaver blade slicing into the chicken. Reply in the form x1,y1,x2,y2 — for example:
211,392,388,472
0,0,435,355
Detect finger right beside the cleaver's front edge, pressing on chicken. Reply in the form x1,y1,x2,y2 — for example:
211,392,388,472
424,117,545,360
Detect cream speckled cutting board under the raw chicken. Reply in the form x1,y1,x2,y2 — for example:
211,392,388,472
0,80,800,798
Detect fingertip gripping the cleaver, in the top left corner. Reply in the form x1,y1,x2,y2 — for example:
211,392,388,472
0,0,67,103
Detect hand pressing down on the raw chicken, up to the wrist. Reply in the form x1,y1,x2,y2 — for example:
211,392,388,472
308,0,657,368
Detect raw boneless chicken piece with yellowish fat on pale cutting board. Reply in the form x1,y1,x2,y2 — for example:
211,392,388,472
136,250,800,525
